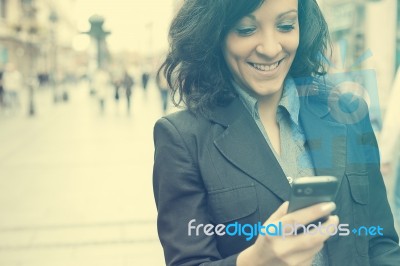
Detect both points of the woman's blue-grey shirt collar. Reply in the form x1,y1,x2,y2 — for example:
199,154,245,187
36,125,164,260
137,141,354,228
233,77,300,125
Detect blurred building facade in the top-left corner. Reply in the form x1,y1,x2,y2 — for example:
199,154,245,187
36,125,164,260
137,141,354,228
0,0,77,84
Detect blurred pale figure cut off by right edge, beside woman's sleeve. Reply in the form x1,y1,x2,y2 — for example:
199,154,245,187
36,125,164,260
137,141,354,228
380,68,400,228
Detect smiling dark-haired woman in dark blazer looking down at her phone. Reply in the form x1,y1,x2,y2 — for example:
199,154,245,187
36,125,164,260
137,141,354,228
153,0,400,265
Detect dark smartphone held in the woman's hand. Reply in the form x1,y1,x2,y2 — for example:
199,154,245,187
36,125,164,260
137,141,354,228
288,176,339,224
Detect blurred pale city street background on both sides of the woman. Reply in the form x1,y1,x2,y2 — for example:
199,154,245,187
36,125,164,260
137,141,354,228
0,0,400,266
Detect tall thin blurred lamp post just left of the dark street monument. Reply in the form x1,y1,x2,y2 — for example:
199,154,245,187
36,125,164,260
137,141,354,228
49,9,58,103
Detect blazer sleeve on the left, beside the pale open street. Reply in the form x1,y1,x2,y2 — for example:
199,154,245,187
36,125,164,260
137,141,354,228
153,118,237,266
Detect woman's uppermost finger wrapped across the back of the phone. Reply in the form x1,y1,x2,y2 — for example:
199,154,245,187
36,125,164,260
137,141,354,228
281,202,336,225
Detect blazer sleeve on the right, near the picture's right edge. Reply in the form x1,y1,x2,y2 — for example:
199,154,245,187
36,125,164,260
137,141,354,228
362,111,400,266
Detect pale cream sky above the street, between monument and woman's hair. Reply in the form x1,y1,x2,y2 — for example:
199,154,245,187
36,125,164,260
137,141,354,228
75,0,172,54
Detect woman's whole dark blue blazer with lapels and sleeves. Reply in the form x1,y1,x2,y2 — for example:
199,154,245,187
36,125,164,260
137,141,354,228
153,90,400,266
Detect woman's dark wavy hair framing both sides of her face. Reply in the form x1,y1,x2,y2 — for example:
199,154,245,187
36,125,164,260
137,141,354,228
157,0,329,112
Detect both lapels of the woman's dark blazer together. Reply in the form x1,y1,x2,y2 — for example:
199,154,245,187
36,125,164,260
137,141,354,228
210,90,347,201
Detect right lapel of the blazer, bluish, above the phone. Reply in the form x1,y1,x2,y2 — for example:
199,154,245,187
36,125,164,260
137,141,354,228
300,96,347,188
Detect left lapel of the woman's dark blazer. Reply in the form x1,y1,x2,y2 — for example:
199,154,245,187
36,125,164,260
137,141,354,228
209,99,290,201
